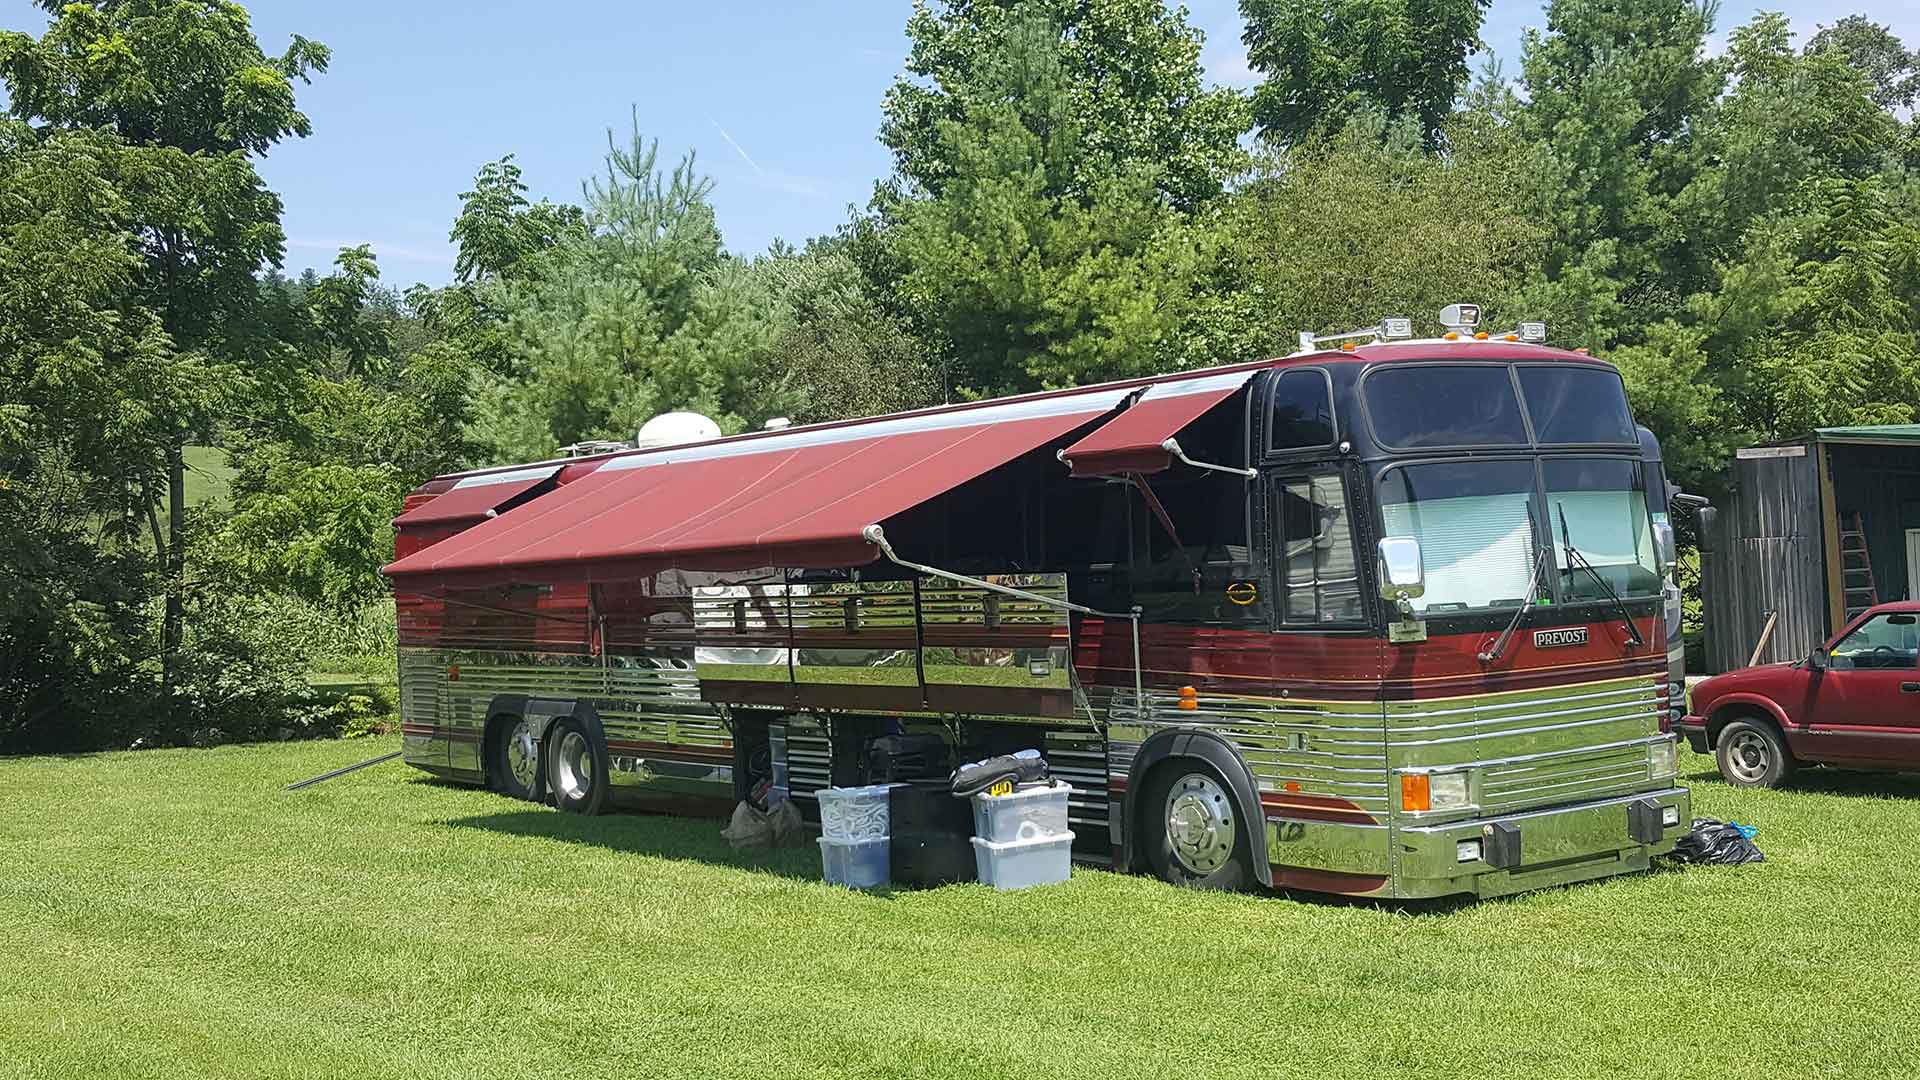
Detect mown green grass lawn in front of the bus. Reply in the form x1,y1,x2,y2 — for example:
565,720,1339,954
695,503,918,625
0,738,1920,1080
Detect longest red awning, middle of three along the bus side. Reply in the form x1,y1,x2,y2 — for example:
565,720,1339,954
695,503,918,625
386,388,1129,590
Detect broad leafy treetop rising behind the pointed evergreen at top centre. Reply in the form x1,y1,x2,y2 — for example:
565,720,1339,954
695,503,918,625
879,0,1246,208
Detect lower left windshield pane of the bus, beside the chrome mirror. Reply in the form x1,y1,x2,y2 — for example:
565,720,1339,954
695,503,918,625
1380,461,1536,615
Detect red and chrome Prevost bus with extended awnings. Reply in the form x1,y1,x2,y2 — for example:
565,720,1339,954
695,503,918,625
386,306,1690,897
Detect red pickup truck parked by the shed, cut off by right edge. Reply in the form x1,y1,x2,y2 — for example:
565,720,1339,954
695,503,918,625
1680,600,1920,788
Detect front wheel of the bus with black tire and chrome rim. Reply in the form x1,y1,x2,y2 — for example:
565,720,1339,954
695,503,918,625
1135,757,1254,892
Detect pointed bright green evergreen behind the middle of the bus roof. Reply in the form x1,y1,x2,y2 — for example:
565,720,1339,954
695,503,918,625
891,15,1194,394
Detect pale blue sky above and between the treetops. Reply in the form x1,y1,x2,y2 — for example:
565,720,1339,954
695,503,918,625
15,0,1920,286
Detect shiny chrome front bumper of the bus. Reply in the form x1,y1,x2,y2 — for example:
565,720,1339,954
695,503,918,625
1392,788,1692,897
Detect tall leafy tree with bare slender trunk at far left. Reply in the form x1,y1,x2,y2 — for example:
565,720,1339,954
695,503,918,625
0,0,328,684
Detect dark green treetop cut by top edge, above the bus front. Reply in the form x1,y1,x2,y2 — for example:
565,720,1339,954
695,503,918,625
1240,0,1488,148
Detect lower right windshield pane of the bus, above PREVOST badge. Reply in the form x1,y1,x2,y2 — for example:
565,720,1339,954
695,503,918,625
1540,457,1661,601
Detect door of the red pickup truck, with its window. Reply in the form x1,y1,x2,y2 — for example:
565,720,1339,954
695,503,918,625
1807,611,1920,769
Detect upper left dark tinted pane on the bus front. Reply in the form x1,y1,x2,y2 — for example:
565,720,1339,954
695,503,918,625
1365,365,1528,450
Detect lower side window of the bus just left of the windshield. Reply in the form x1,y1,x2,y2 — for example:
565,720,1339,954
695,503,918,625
1273,471,1365,626
